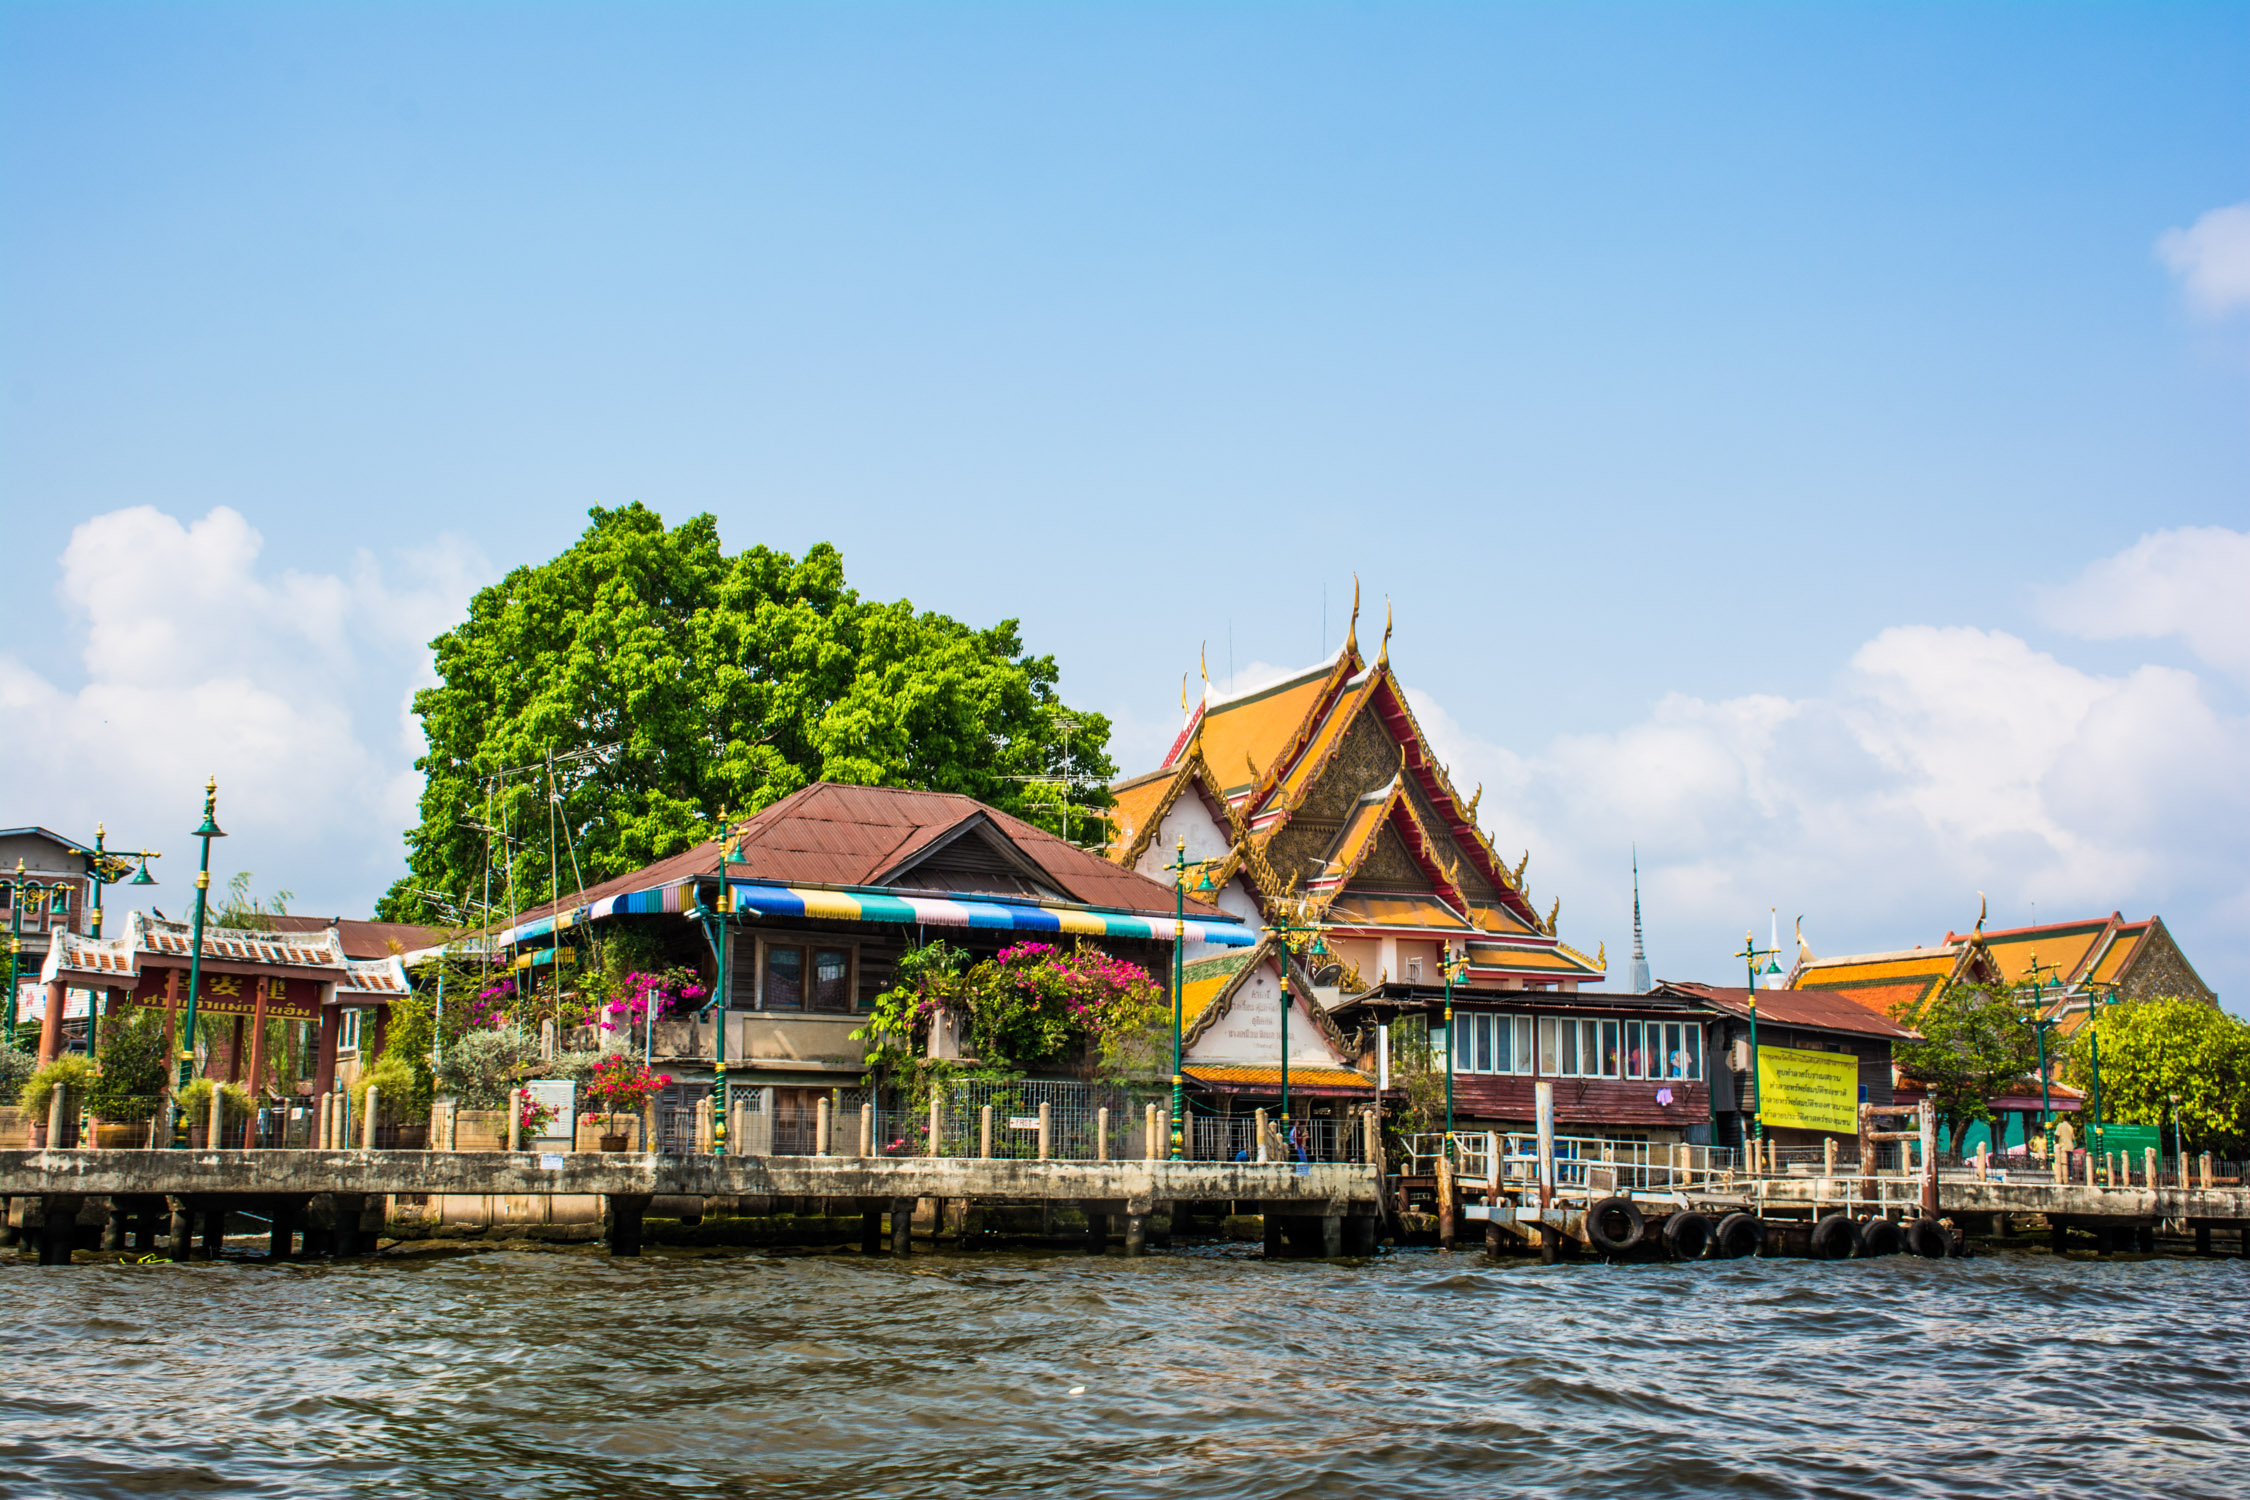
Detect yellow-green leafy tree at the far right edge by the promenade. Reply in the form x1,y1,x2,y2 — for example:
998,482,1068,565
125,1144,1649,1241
2063,996,2250,1156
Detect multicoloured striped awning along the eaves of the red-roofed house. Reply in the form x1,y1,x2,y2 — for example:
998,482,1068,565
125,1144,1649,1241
500,879,1258,947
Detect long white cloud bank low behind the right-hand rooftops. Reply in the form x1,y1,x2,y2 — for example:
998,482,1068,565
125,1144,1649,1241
1413,627,2250,1003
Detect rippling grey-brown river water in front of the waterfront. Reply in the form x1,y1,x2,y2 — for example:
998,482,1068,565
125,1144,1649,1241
0,1248,2250,1500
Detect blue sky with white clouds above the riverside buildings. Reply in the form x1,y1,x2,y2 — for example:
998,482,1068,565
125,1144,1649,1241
0,2,2250,1010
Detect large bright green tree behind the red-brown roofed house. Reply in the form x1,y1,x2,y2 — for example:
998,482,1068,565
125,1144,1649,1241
380,504,1116,920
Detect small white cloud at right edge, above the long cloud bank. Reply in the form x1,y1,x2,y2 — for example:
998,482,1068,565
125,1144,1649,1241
2041,526,2250,686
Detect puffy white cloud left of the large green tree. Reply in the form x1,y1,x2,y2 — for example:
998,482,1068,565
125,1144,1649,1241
0,506,491,915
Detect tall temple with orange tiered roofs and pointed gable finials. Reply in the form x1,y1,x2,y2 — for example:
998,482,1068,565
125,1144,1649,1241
1109,600,1604,1005
